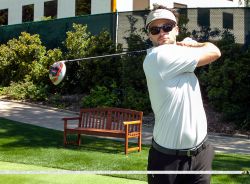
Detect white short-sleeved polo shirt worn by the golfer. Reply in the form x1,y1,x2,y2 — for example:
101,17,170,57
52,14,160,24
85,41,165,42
143,44,207,149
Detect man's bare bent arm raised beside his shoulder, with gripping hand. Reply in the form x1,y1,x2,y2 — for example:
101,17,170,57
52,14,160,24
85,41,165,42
177,39,221,67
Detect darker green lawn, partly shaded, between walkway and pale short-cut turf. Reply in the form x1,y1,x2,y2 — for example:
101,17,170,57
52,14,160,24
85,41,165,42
0,118,250,184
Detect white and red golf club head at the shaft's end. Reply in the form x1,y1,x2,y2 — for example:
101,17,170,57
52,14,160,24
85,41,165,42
49,61,66,85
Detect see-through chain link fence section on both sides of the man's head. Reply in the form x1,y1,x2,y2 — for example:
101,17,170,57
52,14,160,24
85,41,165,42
116,8,250,49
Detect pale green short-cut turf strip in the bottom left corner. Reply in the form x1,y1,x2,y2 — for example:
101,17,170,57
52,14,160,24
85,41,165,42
0,161,146,184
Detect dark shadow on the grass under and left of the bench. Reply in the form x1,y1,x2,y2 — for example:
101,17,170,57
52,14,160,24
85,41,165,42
0,118,142,154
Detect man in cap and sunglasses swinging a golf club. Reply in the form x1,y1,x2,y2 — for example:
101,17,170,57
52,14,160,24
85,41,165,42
143,5,221,184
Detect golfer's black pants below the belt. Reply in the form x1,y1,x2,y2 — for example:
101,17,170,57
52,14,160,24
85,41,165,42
148,144,214,184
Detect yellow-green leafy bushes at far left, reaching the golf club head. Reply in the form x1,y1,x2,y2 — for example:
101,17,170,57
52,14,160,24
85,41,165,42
0,32,62,100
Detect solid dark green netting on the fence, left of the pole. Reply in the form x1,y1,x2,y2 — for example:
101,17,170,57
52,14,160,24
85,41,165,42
0,13,116,49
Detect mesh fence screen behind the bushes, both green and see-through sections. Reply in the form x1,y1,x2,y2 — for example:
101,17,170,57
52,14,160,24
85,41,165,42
0,8,250,49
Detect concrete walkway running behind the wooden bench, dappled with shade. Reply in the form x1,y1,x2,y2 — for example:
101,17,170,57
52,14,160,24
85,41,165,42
0,100,250,154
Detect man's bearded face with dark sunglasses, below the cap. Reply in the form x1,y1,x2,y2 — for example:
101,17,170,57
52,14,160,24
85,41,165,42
148,19,179,46
